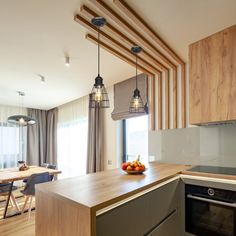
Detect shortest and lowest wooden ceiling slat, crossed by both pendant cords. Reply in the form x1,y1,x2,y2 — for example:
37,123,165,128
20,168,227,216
86,34,155,78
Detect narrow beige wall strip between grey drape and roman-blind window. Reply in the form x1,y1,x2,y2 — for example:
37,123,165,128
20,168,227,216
104,86,122,170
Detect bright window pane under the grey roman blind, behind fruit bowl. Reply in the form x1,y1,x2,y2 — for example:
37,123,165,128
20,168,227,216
124,115,148,163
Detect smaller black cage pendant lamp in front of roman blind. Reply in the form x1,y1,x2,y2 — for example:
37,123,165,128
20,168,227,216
129,46,145,113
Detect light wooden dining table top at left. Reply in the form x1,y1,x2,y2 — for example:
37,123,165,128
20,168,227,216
0,166,61,183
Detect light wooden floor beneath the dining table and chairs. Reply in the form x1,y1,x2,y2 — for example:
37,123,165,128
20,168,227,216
0,187,35,236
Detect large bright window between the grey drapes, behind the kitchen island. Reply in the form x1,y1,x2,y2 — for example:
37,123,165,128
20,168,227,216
57,118,88,178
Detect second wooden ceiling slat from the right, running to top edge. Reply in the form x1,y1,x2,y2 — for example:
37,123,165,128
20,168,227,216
90,0,175,69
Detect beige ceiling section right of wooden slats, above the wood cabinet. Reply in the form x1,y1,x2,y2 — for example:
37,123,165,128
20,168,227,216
127,0,236,61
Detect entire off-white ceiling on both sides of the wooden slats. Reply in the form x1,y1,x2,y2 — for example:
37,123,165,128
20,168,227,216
0,0,236,109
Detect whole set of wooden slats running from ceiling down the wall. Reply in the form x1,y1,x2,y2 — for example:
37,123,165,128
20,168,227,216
74,0,186,129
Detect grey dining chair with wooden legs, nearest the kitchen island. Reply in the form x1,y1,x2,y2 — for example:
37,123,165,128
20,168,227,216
21,172,51,219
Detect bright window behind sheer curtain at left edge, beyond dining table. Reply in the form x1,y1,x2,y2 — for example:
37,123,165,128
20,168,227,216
0,123,27,168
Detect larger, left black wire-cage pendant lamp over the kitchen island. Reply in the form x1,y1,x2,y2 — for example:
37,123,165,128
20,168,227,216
89,17,110,108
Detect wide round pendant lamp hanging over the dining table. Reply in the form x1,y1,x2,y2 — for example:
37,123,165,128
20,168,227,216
7,91,36,126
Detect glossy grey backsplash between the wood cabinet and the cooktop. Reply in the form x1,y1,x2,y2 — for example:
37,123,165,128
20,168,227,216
149,125,236,167
